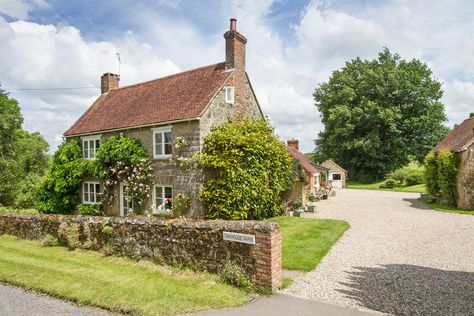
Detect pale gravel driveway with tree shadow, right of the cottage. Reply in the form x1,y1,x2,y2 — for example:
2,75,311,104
284,189,474,315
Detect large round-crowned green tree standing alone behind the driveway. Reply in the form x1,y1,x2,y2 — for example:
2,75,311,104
314,48,447,181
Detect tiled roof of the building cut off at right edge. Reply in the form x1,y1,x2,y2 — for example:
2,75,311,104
433,117,474,152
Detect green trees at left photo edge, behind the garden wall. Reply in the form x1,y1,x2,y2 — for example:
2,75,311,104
0,89,49,208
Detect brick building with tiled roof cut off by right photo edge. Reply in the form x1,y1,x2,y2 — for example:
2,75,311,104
433,116,474,209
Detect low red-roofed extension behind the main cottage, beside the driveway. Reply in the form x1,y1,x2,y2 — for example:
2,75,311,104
287,139,329,206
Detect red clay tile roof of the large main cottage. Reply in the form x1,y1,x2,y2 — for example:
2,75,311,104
64,63,231,136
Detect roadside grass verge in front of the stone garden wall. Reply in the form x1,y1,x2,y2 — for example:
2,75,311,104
0,236,245,315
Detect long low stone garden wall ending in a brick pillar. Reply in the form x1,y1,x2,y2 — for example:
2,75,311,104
0,214,282,290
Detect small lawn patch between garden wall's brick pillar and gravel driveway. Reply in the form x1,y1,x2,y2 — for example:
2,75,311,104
269,216,349,271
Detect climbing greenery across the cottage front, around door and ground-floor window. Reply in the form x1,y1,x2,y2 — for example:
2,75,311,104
36,137,153,214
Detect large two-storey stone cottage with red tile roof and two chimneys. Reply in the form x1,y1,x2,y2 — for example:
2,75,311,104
64,19,263,217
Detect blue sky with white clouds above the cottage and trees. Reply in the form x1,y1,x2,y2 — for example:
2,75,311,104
0,0,474,152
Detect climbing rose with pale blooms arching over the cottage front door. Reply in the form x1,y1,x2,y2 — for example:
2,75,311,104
96,136,154,213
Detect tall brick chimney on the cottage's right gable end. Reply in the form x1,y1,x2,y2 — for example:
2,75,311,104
224,18,247,71
